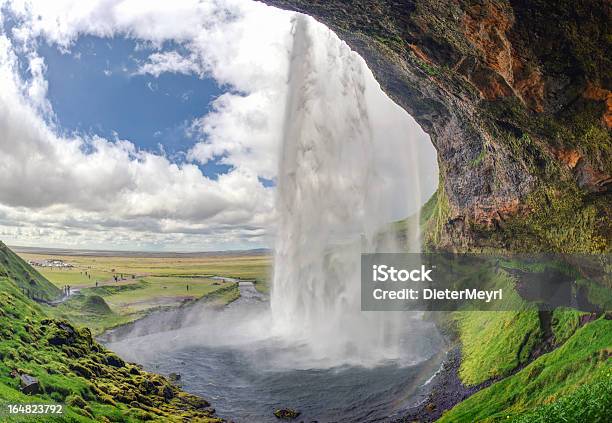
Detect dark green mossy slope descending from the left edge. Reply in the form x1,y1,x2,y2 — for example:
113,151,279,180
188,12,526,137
0,245,221,422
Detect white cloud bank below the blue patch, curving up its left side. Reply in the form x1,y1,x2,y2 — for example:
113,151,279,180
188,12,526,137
0,1,282,249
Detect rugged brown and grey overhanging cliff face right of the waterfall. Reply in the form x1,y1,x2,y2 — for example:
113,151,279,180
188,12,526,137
264,0,612,252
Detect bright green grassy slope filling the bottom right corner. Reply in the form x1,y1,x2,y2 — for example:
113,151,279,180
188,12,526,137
439,318,612,422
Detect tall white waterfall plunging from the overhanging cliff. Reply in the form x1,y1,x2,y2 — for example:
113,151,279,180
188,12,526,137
271,15,428,365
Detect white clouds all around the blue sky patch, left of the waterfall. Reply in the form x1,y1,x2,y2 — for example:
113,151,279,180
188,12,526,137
0,1,290,249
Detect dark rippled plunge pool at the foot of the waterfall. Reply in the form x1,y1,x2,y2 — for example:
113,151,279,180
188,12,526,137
103,285,442,423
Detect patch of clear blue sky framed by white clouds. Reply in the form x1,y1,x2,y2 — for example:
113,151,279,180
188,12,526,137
39,36,231,179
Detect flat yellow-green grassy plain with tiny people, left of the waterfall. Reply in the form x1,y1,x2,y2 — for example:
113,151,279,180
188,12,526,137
19,253,271,334
